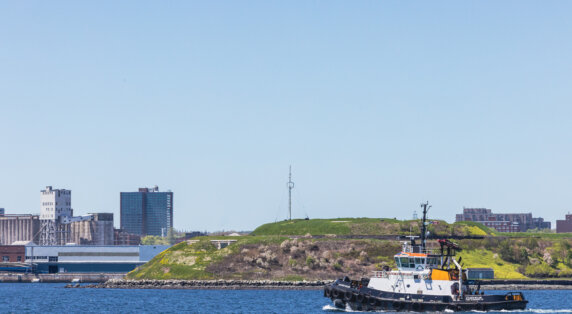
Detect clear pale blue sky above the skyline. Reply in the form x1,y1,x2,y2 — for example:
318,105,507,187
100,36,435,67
0,0,572,231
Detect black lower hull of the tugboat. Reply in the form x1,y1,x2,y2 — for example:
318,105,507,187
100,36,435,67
324,281,528,312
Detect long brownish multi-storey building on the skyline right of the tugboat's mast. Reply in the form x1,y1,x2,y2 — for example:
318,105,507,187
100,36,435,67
455,208,551,232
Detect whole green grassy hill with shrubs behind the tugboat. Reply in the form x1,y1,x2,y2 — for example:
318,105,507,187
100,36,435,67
127,218,572,280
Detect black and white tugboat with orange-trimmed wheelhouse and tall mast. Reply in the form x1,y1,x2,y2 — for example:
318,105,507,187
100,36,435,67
324,203,528,312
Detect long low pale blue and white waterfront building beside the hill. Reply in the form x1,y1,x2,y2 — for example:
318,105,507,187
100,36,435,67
25,244,169,273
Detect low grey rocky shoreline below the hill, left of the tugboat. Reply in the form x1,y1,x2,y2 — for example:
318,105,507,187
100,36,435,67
76,279,331,290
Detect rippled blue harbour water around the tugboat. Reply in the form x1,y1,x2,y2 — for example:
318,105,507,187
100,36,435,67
0,283,572,313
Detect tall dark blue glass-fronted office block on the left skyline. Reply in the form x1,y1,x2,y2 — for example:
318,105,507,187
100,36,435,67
120,186,173,236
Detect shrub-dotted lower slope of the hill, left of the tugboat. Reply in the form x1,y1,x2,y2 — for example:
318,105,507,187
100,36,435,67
128,236,400,280
